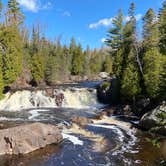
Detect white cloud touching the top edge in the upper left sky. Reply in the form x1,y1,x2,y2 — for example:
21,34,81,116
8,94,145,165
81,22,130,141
18,0,52,12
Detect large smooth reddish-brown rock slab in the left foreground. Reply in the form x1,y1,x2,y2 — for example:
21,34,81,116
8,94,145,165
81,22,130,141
0,123,63,155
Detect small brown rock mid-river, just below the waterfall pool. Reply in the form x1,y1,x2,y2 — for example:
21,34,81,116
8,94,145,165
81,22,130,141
71,116,92,126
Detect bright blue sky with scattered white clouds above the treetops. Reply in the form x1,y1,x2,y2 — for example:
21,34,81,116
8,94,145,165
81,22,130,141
3,0,163,48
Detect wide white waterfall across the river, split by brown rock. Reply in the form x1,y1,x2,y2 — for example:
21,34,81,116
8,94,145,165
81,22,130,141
0,88,102,111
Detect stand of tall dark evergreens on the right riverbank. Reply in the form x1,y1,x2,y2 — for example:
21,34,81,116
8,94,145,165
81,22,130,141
106,1,166,101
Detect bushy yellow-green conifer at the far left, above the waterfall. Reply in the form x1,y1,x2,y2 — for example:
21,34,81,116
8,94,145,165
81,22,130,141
1,26,23,86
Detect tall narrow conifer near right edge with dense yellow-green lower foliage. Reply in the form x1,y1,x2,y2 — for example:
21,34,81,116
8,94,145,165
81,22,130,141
143,9,164,99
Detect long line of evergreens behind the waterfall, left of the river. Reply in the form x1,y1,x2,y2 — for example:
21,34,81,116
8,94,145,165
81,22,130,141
0,0,112,97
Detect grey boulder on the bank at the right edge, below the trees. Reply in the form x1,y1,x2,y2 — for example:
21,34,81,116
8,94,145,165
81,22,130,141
140,105,166,136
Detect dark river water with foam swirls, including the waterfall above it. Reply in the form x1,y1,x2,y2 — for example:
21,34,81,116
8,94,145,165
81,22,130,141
0,82,166,166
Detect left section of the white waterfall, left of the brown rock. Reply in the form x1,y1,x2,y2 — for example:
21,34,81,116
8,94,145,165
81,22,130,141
0,90,56,111
